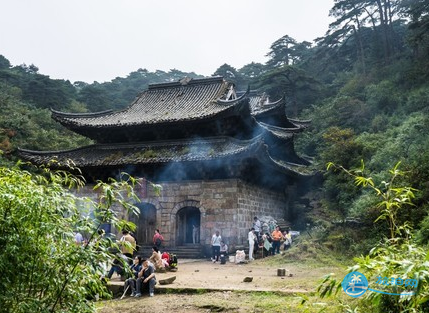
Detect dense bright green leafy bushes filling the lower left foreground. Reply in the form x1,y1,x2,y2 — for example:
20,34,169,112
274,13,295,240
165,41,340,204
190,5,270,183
0,166,139,313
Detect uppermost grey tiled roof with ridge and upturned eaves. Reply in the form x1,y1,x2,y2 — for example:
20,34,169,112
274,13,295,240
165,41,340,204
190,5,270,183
52,77,248,128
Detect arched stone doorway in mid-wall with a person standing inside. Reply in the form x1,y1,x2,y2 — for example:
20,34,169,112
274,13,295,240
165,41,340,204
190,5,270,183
176,206,201,246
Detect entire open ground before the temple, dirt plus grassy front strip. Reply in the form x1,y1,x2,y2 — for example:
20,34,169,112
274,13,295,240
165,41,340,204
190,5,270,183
98,256,341,313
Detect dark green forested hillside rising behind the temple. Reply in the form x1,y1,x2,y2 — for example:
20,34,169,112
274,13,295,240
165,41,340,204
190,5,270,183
0,0,429,254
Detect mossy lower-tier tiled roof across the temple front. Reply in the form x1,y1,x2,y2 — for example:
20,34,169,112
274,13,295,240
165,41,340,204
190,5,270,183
19,137,263,167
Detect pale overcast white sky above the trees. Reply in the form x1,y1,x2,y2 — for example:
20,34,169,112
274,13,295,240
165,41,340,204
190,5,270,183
0,0,334,83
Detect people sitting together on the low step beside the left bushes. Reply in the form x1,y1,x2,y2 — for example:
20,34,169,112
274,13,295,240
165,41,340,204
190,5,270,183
107,229,170,297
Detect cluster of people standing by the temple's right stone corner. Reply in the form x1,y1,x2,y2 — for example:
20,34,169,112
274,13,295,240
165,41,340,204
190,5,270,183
248,216,292,261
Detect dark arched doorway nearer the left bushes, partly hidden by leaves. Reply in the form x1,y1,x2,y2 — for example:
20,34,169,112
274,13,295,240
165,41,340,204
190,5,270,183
131,202,156,245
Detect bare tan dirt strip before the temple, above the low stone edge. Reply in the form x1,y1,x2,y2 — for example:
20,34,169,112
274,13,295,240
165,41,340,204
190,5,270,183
108,256,344,293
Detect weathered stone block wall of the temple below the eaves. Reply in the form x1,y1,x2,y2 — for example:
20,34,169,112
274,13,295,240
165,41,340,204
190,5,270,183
74,179,288,249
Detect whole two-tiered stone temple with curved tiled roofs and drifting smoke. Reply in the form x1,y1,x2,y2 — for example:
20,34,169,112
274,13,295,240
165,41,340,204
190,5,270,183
19,77,309,251
